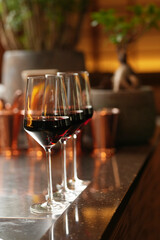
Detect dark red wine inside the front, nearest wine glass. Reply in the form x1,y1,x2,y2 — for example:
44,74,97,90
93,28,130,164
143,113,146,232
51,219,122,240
24,116,71,147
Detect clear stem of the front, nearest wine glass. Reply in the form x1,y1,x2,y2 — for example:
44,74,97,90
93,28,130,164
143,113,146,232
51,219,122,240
45,148,53,206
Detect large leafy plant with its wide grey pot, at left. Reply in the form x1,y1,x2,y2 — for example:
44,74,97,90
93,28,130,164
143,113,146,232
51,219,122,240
0,0,89,101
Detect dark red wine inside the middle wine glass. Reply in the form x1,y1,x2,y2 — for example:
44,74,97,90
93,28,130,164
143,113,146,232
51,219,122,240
64,110,84,137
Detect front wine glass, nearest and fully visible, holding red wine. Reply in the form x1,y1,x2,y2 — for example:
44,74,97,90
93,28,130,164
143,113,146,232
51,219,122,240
24,75,70,215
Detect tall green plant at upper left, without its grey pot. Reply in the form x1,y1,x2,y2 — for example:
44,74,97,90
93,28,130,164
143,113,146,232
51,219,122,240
0,0,89,50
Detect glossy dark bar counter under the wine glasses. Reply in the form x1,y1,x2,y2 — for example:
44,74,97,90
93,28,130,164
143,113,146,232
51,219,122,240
0,135,160,240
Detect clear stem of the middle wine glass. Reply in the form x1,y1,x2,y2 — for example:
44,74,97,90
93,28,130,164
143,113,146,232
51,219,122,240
61,139,68,190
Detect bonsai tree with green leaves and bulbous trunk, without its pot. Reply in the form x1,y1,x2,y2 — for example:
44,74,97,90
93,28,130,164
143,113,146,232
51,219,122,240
92,4,160,91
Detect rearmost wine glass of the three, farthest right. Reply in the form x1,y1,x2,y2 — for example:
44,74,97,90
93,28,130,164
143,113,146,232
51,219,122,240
69,71,93,192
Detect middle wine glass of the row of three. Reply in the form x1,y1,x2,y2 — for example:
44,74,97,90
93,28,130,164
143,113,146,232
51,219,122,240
54,72,84,202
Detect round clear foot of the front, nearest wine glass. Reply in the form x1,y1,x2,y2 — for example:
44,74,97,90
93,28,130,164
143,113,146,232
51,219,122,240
30,202,68,216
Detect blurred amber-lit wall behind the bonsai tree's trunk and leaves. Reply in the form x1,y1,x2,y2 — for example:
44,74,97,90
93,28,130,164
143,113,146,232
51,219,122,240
0,0,160,73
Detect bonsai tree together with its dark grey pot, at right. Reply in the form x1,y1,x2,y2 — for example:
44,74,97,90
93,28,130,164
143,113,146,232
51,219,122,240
92,4,160,145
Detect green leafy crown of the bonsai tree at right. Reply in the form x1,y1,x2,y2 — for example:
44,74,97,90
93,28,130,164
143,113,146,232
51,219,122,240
92,4,160,51
